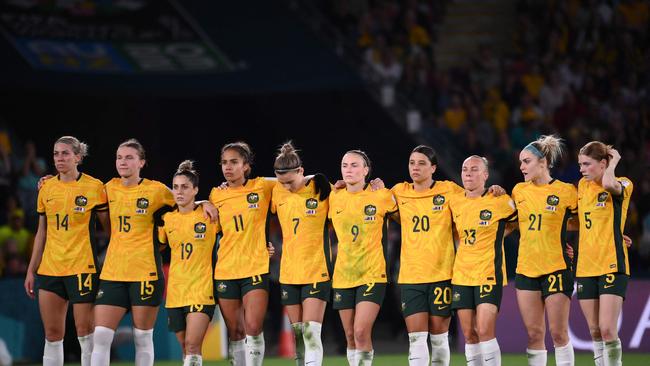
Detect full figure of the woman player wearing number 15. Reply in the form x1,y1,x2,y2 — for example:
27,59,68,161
92,139,174,366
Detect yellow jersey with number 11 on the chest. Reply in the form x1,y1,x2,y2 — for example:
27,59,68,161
210,177,275,280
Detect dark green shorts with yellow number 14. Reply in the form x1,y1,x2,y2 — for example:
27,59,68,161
36,273,99,304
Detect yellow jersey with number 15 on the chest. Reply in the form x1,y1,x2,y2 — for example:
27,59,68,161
100,178,174,282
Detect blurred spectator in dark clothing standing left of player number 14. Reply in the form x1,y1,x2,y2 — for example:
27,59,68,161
16,141,47,229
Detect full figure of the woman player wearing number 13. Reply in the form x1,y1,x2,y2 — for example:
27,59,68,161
450,155,517,366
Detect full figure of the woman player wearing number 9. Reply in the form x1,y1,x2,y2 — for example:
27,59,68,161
328,150,397,365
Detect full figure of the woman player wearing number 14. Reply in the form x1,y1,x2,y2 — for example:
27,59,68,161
25,136,110,366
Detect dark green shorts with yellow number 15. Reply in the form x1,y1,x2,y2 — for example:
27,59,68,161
95,274,165,309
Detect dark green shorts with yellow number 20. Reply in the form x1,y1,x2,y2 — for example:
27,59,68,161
399,280,451,318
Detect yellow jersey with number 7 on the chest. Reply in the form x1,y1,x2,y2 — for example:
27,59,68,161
271,180,331,285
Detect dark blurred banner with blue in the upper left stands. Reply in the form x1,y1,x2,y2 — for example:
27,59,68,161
0,0,234,74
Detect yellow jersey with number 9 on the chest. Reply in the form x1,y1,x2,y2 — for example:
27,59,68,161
328,185,397,288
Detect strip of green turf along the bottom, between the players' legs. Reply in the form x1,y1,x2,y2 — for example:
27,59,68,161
43,353,650,366
